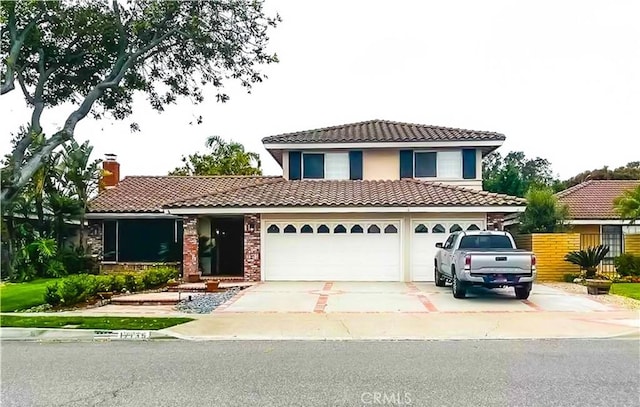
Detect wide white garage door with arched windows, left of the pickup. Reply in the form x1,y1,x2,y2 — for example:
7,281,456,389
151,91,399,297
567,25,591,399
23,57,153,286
262,220,401,281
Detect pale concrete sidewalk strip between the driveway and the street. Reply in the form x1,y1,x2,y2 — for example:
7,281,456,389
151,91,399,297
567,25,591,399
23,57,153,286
163,311,640,340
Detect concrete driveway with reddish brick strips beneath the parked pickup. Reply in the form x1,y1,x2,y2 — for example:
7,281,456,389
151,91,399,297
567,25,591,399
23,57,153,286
215,282,616,314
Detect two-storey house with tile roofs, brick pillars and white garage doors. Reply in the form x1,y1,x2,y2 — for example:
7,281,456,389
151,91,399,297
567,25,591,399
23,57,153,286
89,120,525,281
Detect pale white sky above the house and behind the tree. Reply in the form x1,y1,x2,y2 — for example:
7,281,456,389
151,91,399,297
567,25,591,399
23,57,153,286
0,0,640,178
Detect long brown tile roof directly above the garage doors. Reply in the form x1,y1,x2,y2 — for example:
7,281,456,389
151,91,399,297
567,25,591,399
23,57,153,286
167,179,525,208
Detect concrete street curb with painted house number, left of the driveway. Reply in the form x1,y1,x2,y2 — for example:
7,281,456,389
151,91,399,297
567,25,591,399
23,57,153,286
0,327,176,342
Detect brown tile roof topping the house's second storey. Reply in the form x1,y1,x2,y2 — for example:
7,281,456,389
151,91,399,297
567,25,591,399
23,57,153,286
262,120,505,144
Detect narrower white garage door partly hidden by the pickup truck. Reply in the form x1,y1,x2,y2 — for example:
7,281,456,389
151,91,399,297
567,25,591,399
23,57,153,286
411,219,484,281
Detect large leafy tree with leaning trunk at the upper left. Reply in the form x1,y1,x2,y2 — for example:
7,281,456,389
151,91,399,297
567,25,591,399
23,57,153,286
0,0,279,207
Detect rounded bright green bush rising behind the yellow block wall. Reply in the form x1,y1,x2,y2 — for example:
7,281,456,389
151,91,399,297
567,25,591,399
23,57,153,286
519,187,569,233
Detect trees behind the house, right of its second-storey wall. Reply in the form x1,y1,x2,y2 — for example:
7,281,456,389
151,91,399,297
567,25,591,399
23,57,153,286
482,151,554,197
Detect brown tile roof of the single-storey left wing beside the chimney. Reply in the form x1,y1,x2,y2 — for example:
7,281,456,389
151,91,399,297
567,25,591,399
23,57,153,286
89,176,281,213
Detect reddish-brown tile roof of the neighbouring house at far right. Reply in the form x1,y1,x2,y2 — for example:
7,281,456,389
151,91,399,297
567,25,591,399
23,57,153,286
556,180,640,219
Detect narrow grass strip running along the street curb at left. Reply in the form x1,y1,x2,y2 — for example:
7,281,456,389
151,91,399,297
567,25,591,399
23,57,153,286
0,315,193,330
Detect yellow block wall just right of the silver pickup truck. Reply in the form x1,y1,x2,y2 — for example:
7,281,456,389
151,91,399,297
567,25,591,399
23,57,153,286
528,233,580,281
